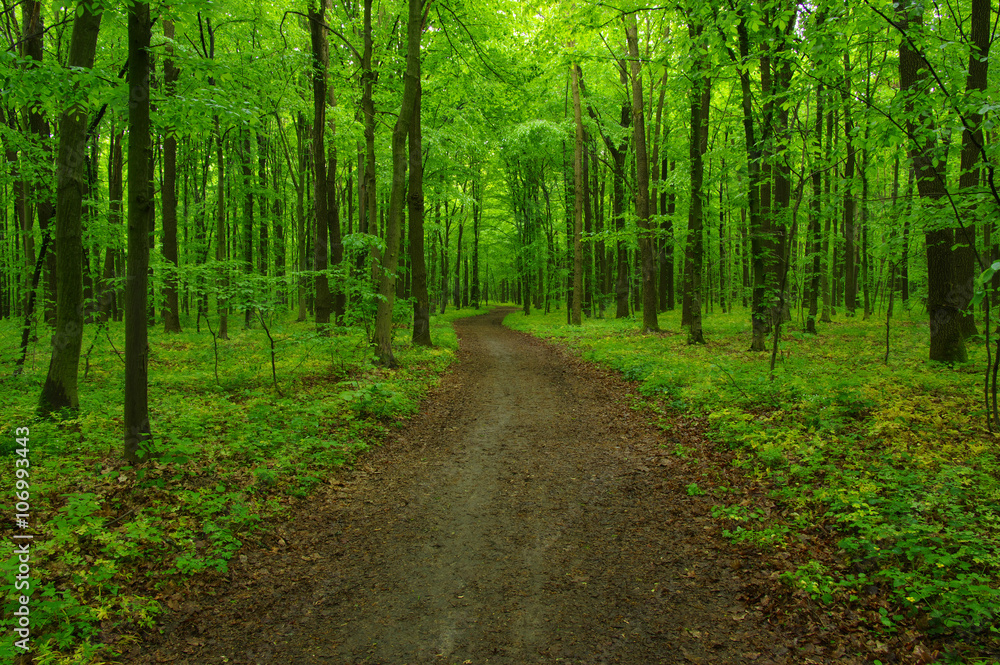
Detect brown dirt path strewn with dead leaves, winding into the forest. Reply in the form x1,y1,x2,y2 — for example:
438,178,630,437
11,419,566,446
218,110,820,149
125,309,931,665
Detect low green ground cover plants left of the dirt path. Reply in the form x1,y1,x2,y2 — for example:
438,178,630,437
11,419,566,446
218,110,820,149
0,309,481,663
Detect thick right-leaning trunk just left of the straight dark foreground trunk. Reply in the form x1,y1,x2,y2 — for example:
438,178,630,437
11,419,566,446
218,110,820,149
38,6,101,415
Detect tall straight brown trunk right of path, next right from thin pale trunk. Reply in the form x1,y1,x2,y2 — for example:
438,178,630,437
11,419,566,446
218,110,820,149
625,13,660,332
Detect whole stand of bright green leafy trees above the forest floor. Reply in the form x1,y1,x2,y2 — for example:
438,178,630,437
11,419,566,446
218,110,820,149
0,0,998,464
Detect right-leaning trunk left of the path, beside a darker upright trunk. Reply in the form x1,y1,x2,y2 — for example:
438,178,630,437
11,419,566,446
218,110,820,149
376,0,423,367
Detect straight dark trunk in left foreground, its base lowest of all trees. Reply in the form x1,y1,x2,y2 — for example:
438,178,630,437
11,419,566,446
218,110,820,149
124,2,153,464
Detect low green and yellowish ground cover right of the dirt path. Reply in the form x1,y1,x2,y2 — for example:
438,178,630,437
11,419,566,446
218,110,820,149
506,304,1000,662
